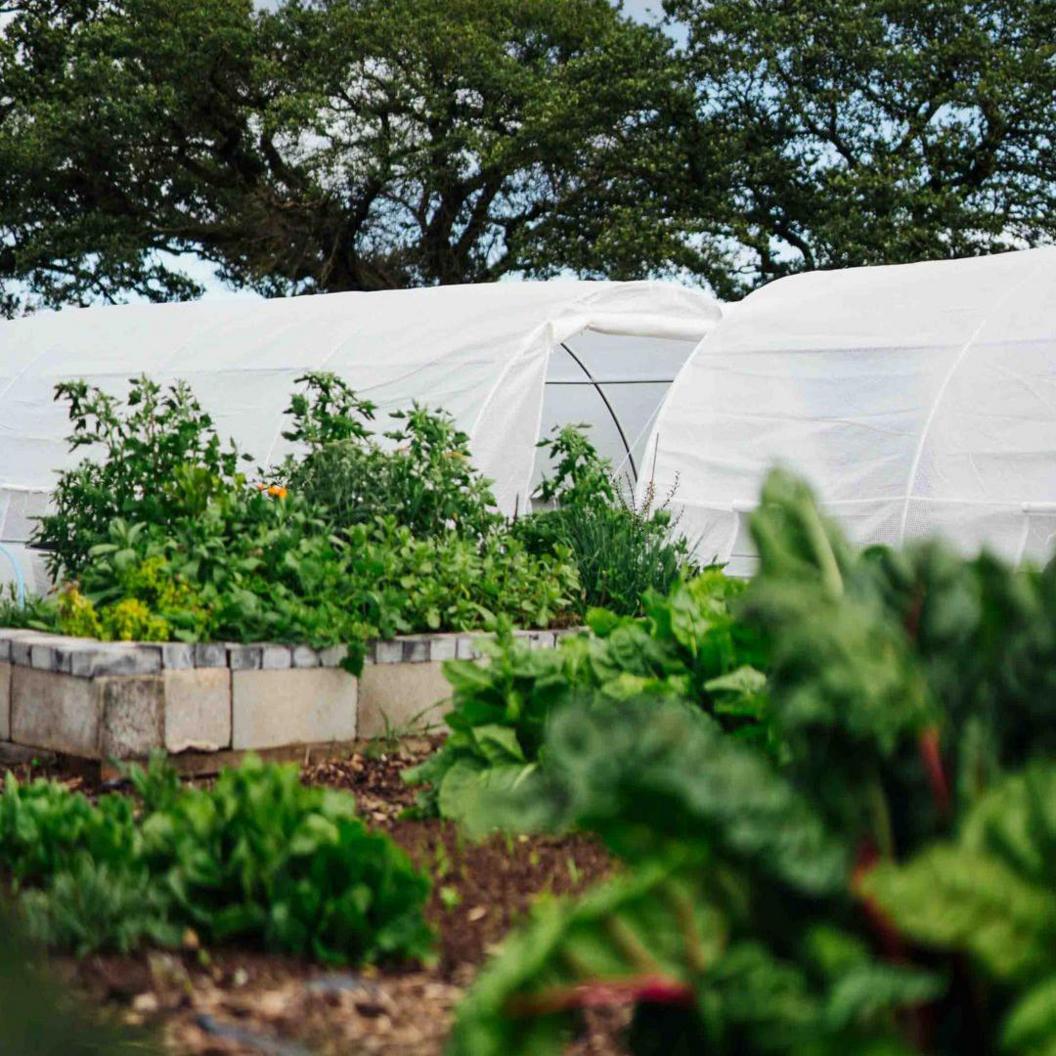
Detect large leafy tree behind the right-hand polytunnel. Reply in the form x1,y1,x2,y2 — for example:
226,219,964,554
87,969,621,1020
664,0,1056,296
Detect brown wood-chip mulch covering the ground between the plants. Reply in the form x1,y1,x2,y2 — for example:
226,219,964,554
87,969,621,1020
19,739,625,1056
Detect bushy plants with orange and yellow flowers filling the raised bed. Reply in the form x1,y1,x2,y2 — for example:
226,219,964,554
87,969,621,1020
18,374,581,672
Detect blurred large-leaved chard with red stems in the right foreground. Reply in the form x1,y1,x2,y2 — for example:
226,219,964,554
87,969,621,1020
451,473,1056,1056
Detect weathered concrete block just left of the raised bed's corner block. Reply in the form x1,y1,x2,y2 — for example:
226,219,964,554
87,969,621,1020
11,666,100,759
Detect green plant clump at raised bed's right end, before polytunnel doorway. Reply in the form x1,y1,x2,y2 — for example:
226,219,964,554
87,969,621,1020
513,426,695,616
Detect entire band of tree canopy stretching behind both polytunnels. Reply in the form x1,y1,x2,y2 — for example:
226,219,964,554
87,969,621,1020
0,0,1056,315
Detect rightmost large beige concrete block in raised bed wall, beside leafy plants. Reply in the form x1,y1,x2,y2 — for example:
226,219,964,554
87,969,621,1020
358,660,451,738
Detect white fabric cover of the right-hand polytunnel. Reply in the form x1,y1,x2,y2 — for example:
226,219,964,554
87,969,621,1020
648,248,1056,572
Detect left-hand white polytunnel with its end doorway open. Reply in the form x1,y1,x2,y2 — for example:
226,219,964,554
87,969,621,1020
0,281,721,589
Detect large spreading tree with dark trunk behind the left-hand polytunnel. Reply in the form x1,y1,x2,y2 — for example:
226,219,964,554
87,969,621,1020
0,0,690,315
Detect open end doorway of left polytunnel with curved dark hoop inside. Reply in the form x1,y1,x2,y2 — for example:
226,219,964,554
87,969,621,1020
531,329,696,505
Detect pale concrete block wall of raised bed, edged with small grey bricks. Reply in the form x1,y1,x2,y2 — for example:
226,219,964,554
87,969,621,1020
0,628,570,772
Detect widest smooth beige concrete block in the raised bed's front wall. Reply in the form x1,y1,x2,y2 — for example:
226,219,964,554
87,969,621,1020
231,667,358,750
